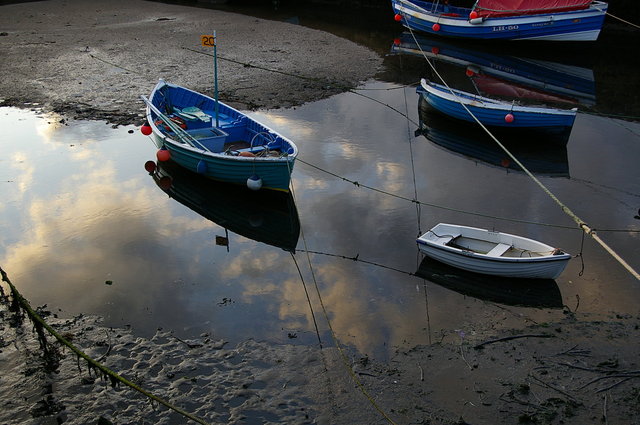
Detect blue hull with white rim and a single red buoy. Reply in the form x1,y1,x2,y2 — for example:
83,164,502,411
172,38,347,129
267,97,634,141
418,80,576,128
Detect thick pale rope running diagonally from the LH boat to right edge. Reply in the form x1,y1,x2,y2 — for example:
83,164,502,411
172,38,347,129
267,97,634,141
405,22,640,280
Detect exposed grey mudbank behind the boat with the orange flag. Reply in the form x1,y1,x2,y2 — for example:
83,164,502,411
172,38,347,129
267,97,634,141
0,0,382,124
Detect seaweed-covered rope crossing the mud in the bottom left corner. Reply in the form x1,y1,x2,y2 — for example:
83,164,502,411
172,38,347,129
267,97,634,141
0,267,215,425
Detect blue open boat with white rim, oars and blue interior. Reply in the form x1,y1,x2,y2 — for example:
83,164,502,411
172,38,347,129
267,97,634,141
143,80,298,192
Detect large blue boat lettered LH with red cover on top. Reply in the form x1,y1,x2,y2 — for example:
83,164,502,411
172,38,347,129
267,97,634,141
391,0,608,41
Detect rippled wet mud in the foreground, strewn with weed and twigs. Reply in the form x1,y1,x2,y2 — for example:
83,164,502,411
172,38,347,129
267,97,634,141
0,288,640,425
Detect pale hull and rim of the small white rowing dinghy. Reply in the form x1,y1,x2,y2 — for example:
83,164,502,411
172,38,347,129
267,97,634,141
417,223,571,279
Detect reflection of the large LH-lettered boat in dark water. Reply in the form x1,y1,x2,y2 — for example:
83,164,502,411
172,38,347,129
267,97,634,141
391,33,596,107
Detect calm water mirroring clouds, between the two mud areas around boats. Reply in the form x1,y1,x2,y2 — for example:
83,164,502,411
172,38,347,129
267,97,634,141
0,7,640,358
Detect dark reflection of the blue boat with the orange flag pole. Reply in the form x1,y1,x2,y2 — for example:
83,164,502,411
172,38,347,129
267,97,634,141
145,161,300,252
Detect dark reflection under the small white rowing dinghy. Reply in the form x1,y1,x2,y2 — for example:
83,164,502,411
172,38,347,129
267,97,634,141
415,257,563,308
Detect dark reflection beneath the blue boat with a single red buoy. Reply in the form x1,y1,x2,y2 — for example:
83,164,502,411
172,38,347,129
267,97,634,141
416,96,571,177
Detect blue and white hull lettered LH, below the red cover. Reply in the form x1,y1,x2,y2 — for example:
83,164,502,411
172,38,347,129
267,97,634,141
392,0,608,41
